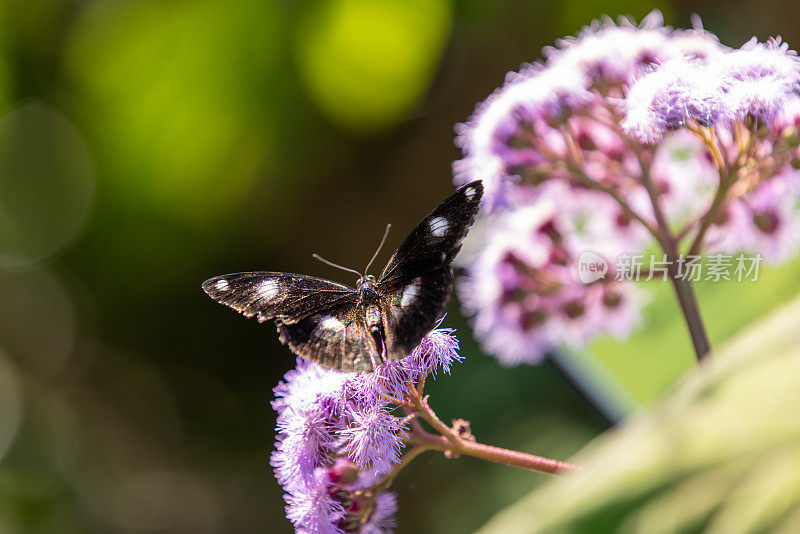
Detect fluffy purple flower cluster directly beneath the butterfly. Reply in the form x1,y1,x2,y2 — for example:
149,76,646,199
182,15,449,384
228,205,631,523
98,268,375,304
270,329,461,534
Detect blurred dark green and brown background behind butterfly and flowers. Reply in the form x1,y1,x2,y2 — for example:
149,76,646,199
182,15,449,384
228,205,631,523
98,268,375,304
0,0,800,534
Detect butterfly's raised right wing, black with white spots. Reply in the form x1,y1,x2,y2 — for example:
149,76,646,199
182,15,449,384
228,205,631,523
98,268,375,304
378,181,483,361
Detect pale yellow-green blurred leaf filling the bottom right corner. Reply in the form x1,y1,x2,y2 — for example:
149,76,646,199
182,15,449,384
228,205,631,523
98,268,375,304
481,298,800,534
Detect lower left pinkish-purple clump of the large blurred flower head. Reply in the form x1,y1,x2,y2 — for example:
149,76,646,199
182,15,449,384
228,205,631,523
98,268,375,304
458,186,649,365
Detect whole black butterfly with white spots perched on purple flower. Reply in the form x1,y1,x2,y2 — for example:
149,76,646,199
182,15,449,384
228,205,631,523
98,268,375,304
203,180,483,372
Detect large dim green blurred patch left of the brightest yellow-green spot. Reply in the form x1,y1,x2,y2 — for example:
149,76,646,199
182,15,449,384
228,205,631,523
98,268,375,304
66,0,285,224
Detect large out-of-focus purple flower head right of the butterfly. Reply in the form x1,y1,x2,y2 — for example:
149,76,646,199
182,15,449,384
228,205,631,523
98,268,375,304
453,11,800,364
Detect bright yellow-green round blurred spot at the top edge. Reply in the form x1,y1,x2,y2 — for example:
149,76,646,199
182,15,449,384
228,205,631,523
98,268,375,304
295,0,453,131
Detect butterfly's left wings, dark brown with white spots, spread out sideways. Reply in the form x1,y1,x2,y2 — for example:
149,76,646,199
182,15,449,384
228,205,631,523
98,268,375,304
203,272,375,371
